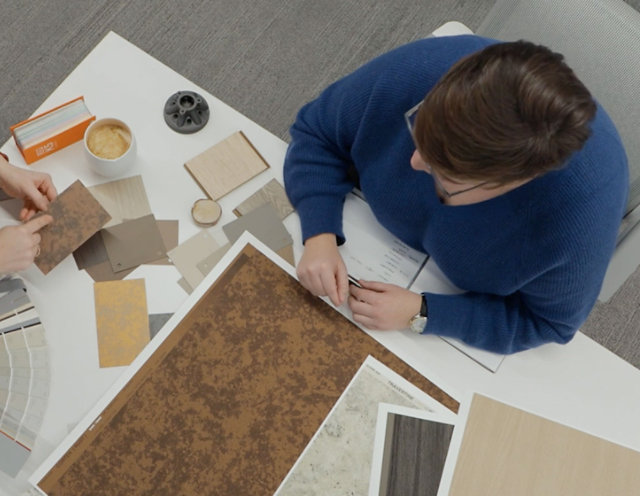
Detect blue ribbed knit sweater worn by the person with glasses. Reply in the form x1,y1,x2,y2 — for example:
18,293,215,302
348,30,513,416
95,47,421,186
284,36,628,353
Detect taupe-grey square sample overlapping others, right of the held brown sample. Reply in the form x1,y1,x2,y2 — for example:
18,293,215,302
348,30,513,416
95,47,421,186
100,215,166,272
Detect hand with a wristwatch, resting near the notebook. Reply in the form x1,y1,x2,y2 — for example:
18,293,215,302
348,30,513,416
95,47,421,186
349,281,422,331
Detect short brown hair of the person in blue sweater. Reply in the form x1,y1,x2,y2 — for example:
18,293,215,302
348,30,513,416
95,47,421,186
414,41,596,185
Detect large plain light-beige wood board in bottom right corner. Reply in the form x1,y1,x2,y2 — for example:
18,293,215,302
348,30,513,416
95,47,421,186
449,394,640,496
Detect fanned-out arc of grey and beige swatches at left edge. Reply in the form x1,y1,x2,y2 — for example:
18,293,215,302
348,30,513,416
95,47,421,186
0,277,50,477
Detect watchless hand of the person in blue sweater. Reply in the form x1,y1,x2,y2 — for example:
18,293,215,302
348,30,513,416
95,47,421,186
296,233,349,306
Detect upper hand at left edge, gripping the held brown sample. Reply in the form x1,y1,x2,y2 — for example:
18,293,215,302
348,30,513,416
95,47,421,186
0,160,58,221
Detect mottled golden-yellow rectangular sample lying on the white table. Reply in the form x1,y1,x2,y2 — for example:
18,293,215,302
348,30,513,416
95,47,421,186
93,279,150,367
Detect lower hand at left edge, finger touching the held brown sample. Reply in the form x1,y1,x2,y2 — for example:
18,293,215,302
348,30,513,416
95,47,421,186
0,215,53,274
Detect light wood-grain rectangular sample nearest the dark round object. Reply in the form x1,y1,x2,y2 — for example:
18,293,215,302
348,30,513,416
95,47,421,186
184,131,269,200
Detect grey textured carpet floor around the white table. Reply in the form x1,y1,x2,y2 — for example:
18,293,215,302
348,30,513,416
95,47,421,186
0,0,640,367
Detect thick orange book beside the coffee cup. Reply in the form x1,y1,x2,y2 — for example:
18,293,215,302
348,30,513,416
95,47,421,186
11,96,95,164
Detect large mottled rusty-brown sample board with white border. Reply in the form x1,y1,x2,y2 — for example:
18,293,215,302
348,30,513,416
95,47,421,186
38,246,458,496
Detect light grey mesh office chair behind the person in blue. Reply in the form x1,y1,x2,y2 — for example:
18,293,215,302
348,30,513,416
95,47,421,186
476,0,640,300
